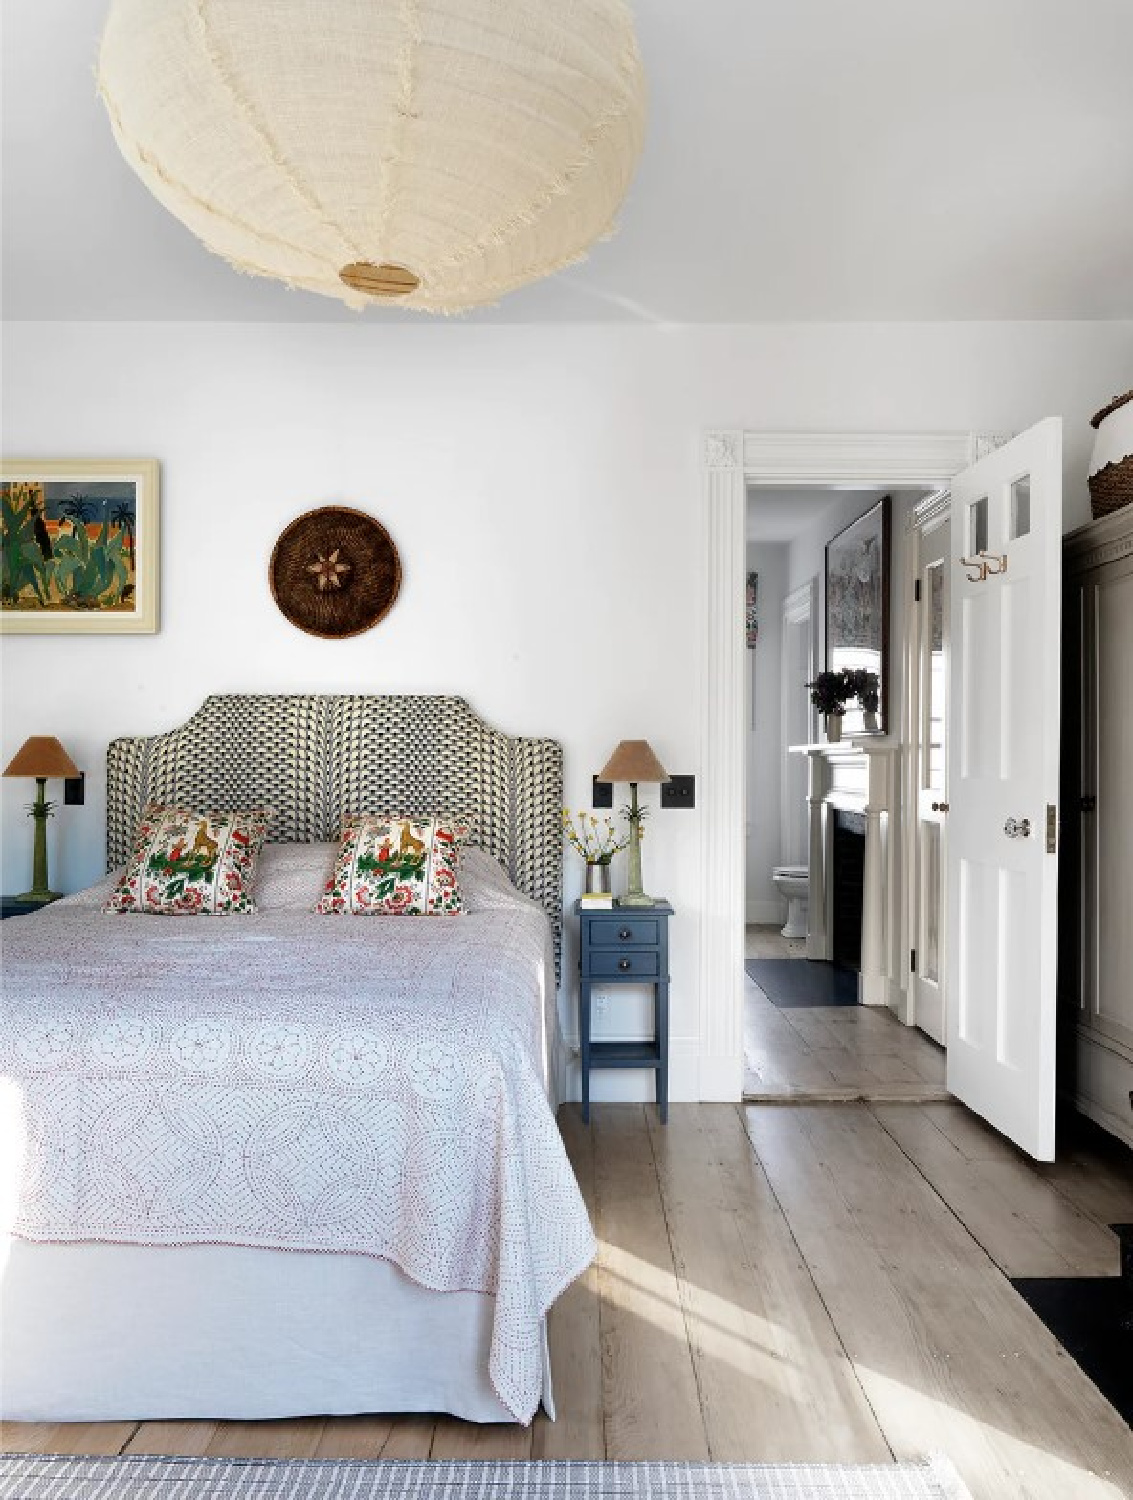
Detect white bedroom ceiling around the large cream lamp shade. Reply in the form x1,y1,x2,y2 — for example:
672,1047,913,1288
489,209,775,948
3,0,1133,323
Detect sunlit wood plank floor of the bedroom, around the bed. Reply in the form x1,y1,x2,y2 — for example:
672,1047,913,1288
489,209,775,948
5,1104,1133,1500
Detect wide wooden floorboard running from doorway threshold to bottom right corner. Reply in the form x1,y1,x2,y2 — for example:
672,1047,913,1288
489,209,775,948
744,1106,1133,1500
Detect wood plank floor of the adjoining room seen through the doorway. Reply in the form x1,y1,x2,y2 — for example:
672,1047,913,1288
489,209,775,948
744,927,950,1103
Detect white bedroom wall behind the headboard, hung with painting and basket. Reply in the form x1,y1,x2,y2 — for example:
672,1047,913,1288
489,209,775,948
0,318,1133,1095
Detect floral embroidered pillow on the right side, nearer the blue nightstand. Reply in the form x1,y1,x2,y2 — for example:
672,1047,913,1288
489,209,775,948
315,815,468,917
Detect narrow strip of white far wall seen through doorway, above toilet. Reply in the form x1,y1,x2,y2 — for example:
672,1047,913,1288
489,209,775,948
746,542,786,923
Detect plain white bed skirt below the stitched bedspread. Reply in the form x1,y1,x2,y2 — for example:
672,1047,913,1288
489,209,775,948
0,1239,554,1422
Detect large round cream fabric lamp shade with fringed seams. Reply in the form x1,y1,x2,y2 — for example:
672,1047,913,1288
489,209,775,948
99,0,645,312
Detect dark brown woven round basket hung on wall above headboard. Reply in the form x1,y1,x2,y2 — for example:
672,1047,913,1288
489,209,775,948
267,506,401,641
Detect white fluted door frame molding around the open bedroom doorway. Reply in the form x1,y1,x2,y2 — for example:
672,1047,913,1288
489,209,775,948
698,428,1004,1101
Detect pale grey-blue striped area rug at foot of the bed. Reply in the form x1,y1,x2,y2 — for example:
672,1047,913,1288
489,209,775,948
0,1454,971,1500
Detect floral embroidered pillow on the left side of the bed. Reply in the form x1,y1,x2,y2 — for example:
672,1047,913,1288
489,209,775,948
104,803,272,917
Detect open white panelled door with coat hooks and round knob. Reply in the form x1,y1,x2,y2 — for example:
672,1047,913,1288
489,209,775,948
945,417,1062,1161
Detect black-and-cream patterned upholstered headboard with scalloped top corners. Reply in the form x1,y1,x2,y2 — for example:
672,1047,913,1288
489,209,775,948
107,693,563,959
